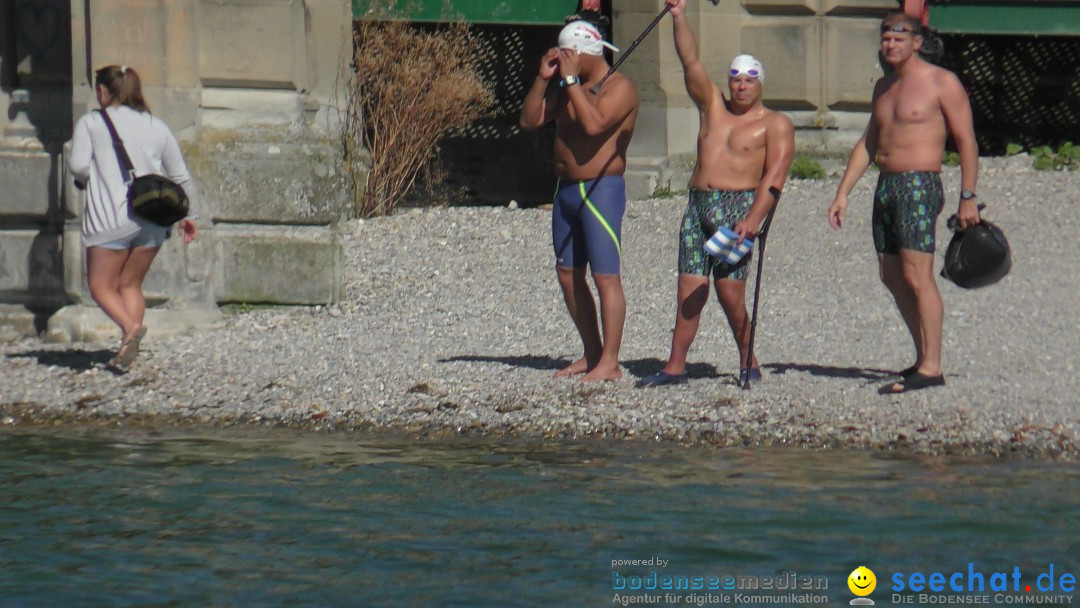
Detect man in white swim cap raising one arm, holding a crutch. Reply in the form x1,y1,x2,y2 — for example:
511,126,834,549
637,0,795,387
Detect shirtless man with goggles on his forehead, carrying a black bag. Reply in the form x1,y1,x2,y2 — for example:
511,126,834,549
828,13,980,393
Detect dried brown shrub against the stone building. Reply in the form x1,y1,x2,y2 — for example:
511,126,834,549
343,13,495,217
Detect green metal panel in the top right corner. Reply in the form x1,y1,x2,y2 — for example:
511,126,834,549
930,0,1080,36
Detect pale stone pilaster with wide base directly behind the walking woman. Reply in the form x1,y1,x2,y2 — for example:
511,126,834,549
44,0,220,341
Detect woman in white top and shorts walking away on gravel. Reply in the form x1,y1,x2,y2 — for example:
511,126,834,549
68,66,198,370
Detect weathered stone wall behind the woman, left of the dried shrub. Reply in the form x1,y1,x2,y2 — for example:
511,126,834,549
0,0,352,340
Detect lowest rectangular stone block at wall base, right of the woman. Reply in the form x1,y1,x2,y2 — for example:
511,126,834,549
213,224,345,305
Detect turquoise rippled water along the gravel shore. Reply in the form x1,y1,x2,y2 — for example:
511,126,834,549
0,431,1080,607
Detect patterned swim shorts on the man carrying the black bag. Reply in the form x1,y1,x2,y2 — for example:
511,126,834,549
874,171,945,255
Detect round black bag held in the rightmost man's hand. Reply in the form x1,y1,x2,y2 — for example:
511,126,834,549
942,219,1012,289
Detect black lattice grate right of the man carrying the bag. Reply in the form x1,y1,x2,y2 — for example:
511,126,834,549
943,36,1080,154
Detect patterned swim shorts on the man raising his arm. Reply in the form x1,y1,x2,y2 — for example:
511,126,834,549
678,190,756,281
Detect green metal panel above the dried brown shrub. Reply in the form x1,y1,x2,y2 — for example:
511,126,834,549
352,0,578,25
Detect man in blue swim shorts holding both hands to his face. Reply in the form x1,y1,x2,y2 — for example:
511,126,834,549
521,11,638,381
